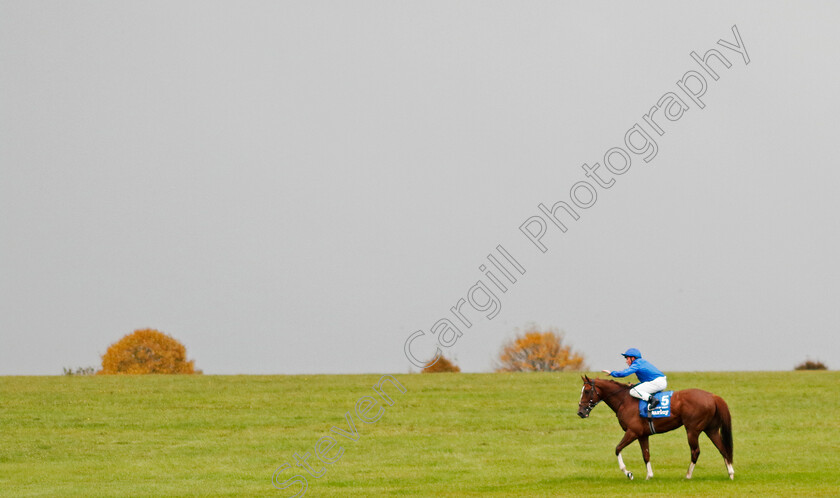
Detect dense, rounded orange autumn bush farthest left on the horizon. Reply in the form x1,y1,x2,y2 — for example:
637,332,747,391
96,329,201,375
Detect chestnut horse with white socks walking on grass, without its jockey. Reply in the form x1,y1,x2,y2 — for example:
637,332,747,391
578,376,735,479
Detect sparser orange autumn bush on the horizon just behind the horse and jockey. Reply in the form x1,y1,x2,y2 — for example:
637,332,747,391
496,327,586,372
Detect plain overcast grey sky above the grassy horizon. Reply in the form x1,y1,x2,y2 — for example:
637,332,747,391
0,1,840,374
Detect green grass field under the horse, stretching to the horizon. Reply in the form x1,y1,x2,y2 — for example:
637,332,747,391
0,372,840,497
